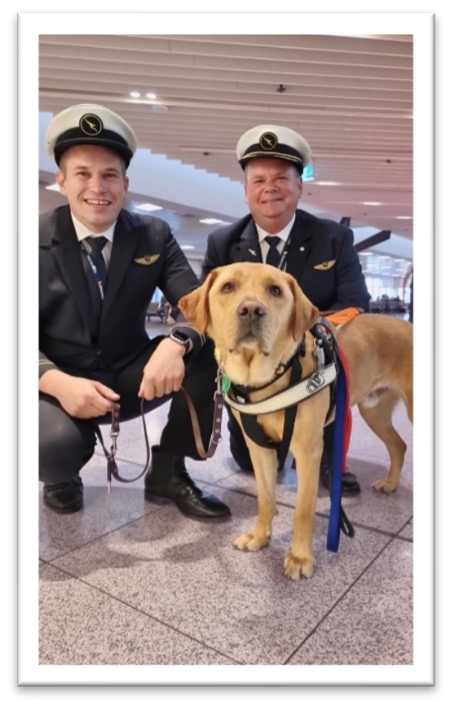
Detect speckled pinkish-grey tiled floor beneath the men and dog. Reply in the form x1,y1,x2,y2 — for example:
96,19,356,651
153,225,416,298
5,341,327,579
39,320,413,666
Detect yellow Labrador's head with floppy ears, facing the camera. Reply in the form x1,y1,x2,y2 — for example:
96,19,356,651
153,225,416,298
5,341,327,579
179,263,319,385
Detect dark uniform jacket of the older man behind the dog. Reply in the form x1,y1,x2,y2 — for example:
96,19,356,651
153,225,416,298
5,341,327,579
201,209,371,312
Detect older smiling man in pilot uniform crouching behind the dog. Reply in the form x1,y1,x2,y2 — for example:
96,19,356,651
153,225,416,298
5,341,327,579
202,125,370,494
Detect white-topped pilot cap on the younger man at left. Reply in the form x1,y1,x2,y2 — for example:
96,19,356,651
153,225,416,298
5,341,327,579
46,103,137,167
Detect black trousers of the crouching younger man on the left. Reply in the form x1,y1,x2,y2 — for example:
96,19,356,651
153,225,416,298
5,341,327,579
39,337,217,484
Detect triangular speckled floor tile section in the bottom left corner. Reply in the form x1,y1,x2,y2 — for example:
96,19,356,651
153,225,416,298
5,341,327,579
39,566,234,664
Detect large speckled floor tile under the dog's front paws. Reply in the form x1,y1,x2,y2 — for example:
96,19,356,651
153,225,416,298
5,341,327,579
49,493,387,664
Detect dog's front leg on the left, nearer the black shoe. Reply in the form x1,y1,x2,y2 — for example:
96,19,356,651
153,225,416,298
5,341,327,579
234,443,278,551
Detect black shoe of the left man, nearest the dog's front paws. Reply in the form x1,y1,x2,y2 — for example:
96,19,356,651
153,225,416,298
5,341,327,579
144,447,231,519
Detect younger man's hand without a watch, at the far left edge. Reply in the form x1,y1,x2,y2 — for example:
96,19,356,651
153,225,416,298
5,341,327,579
39,369,120,418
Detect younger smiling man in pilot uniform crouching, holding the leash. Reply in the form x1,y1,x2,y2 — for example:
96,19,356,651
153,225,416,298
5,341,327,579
39,104,229,518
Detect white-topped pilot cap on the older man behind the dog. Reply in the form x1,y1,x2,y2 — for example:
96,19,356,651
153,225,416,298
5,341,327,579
237,125,311,174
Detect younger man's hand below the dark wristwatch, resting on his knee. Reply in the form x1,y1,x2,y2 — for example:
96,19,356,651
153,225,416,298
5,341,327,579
138,338,185,401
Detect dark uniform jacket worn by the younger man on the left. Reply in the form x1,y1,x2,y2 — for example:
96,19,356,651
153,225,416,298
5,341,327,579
39,206,199,377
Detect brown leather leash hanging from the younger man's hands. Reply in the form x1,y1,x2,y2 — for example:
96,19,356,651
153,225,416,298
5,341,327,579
96,374,224,492
